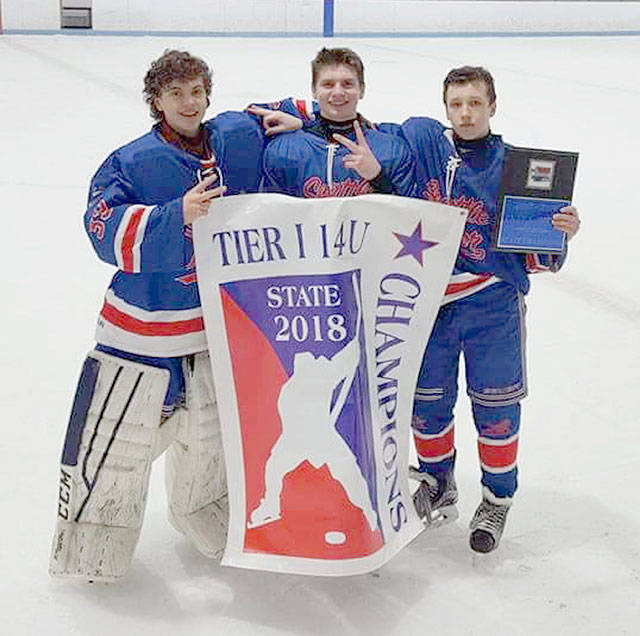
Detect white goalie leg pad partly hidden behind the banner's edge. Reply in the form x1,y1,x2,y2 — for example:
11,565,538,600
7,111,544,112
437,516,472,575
165,352,229,558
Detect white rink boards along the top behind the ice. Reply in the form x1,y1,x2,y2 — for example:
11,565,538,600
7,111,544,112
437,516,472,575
0,0,640,35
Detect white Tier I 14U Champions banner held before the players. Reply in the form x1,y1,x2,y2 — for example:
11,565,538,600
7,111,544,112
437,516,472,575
193,194,466,576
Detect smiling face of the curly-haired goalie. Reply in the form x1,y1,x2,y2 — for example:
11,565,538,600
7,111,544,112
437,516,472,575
153,77,209,137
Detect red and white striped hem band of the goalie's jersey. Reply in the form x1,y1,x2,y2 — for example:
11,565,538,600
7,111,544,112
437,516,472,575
96,289,207,357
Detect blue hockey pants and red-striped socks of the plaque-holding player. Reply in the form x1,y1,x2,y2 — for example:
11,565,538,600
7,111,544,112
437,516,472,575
413,283,527,499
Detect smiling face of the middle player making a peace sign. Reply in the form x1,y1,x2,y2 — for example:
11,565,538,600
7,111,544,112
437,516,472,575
312,64,364,121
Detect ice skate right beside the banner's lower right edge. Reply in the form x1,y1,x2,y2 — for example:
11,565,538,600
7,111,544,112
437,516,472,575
409,466,458,528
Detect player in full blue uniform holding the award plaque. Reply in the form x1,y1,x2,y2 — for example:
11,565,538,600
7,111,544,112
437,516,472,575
401,66,580,552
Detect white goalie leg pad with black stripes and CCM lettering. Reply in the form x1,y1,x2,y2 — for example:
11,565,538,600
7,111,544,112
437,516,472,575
49,351,169,581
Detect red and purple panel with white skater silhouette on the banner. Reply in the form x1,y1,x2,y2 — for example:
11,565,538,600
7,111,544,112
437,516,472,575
220,271,384,559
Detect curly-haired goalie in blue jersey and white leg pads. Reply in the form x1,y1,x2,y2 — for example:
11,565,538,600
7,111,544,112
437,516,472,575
50,51,270,581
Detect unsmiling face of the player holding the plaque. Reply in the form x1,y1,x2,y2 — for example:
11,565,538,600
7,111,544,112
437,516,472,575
445,80,496,141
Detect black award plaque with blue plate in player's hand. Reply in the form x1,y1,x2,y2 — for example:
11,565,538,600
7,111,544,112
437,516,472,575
493,146,578,254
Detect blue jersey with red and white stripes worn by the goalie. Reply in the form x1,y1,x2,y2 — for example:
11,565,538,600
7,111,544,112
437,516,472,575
84,112,264,357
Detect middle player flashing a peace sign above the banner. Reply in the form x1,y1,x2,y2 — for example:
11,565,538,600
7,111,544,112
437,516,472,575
252,48,415,198
